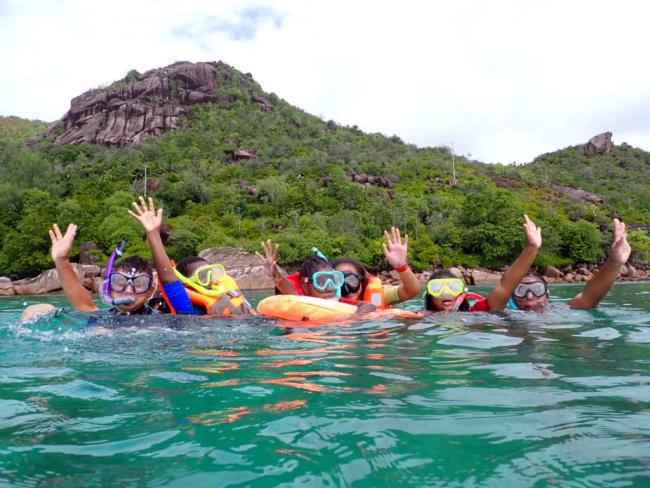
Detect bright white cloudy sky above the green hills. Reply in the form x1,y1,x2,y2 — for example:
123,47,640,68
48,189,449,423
0,0,650,163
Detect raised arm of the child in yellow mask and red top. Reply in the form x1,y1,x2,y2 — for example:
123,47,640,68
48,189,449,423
487,215,542,310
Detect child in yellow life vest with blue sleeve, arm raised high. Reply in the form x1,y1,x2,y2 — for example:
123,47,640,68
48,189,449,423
129,197,255,316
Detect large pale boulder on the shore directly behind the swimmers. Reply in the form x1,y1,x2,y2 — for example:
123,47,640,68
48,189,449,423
199,247,275,290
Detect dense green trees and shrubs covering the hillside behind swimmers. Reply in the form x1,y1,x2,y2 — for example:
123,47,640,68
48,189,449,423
0,66,650,277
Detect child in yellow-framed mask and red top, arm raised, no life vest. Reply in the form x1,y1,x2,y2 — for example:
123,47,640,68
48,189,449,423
424,215,542,312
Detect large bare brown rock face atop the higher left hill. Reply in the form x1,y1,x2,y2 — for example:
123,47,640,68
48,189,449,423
28,61,274,147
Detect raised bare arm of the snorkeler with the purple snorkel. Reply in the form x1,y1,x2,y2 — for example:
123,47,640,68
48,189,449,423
49,224,98,312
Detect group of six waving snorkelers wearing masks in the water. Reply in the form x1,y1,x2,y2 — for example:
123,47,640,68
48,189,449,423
23,197,631,320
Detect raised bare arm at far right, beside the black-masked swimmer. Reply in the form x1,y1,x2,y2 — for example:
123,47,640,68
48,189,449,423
569,219,632,308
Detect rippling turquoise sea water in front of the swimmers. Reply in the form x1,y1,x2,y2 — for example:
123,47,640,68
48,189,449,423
0,283,650,488
